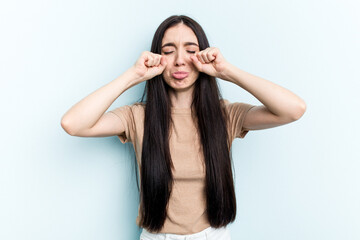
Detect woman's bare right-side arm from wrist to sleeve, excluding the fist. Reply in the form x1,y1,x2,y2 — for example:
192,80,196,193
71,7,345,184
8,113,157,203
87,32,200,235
221,63,306,130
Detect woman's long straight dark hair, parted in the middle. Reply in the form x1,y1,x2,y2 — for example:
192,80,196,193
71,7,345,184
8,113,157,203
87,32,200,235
139,15,236,232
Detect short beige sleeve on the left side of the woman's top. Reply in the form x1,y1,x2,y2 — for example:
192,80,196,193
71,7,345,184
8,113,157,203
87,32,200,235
109,105,134,143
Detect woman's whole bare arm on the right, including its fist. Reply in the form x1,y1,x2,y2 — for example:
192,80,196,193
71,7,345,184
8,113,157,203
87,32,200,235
191,47,306,130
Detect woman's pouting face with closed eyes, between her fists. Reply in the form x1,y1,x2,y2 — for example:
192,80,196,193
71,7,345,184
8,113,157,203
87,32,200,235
161,23,199,91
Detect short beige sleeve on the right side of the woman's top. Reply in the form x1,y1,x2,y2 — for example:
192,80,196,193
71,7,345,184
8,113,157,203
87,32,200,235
225,100,256,140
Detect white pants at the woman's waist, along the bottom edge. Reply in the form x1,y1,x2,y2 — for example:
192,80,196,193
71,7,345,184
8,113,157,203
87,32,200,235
140,227,231,240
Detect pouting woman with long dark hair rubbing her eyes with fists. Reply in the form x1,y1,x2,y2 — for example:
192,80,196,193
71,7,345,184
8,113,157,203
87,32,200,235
61,15,306,240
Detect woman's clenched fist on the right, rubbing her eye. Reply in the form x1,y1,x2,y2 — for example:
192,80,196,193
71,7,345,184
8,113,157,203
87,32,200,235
190,47,228,79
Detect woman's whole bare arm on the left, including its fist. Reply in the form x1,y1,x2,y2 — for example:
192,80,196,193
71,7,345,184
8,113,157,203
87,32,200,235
61,51,166,137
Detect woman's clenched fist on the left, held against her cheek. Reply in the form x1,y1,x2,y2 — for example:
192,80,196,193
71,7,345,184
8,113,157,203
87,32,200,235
133,51,167,81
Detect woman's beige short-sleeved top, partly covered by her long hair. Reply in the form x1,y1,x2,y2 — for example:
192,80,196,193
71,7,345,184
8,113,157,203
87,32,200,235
110,100,254,234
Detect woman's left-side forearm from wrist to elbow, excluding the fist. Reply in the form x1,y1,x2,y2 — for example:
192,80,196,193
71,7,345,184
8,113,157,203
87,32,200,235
61,68,141,134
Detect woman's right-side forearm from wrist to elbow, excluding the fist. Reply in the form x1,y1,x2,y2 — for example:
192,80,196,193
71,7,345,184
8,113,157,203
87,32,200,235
221,64,306,120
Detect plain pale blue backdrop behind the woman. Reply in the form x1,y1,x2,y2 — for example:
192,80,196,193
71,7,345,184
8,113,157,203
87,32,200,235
0,0,360,240
